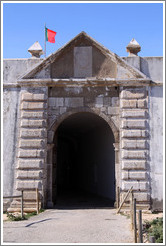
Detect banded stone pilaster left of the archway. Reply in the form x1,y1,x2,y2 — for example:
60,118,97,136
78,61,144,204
9,88,47,212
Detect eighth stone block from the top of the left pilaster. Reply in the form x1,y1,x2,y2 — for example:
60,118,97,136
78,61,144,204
18,159,44,169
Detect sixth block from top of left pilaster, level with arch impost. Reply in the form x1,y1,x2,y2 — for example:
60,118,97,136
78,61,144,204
19,139,46,148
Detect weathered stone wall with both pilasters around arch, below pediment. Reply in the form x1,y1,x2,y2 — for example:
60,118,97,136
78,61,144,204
3,33,163,211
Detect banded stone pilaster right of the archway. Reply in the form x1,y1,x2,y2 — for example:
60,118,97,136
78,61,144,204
120,87,150,209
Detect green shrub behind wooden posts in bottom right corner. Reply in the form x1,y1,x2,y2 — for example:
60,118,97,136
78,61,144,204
145,217,163,243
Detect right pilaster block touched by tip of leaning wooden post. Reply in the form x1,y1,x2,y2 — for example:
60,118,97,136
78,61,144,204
122,181,148,191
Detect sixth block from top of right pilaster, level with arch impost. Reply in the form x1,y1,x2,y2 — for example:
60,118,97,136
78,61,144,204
122,139,148,149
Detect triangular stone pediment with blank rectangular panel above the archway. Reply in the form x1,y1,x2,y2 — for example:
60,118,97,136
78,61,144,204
21,32,147,79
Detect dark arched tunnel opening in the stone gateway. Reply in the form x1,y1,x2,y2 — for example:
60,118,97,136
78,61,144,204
53,112,115,207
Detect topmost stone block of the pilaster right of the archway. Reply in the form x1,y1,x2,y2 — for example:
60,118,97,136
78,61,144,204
121,88,146,99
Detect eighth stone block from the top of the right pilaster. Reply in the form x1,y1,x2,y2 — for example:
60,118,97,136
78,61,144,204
122,160,146,170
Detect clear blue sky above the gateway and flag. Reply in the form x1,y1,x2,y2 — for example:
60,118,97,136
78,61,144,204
3,2,163,58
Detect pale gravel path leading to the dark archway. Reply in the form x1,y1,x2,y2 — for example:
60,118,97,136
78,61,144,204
3,208,133,243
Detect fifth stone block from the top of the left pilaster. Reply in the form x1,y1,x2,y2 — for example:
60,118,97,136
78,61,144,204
20,129,47,138
